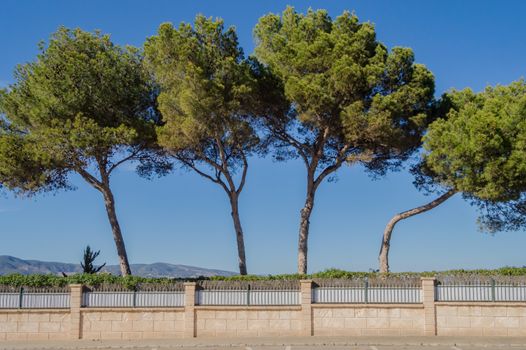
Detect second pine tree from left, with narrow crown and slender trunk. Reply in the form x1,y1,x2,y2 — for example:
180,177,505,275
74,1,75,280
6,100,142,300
145,15,287,275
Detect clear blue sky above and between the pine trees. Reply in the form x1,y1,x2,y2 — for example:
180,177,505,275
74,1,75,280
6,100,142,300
0,0,526,274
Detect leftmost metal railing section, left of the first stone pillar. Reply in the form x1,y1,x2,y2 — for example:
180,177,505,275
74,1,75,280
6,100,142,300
0,288,70,309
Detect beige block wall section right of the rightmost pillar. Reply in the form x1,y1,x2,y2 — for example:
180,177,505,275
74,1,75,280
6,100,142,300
436,303,526,336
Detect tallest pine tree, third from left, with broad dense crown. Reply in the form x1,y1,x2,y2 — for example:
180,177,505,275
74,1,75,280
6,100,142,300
254,7,434,274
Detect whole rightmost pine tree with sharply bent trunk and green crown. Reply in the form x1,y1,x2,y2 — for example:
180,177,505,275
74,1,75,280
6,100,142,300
379,80,526,272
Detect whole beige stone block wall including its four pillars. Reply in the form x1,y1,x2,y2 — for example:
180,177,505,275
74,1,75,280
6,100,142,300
0,278,526,341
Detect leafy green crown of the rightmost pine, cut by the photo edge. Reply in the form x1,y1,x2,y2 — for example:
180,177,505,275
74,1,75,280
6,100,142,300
424,80,526,201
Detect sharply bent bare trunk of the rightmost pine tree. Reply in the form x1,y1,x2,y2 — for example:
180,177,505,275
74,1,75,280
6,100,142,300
378,190,456,273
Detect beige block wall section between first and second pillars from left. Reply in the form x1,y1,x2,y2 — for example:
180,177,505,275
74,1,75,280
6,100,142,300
80,308,185,339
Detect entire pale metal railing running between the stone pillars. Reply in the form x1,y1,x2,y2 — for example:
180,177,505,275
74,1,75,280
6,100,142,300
0,276,526,309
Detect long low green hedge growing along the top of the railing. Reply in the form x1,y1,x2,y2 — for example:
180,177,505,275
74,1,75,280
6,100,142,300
0,267,526,288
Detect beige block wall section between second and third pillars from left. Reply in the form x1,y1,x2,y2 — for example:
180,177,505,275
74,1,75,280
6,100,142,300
195,306,303,337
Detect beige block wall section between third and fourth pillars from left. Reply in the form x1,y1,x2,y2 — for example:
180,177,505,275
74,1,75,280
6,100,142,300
313,304,424,336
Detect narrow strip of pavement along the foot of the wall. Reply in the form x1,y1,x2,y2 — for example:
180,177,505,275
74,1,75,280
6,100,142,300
4,337,526,350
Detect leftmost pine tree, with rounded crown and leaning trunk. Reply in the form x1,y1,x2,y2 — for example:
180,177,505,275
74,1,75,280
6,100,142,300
0,28,169,275
